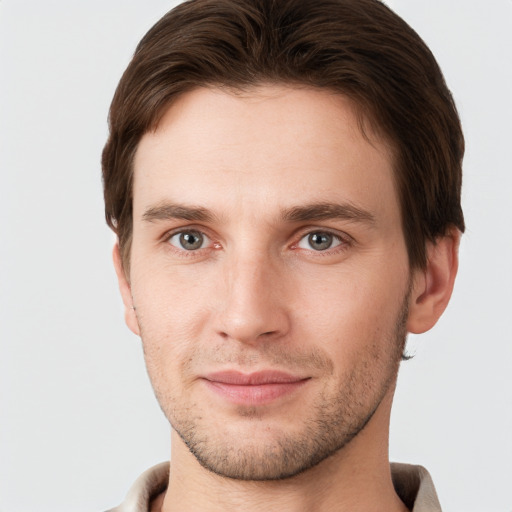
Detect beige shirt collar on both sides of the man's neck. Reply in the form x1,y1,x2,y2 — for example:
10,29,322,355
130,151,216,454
107,462,441,512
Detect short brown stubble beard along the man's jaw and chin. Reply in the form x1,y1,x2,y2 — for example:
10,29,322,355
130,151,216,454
139,293,409,481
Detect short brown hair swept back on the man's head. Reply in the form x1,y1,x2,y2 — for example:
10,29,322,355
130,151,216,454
102,0,464,271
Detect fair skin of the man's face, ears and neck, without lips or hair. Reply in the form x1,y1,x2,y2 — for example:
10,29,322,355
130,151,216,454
114,86,459,512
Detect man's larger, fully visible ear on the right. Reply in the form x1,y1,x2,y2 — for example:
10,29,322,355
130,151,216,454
407,227,461,334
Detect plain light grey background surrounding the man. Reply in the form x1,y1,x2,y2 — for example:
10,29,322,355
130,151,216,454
0,0,512,512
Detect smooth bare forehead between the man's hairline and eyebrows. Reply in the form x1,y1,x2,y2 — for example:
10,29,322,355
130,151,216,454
134,86,398,227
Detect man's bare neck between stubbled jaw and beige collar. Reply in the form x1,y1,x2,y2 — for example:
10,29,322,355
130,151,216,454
160,390,407,512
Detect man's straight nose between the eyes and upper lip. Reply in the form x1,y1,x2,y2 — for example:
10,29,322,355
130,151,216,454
217,251,290,344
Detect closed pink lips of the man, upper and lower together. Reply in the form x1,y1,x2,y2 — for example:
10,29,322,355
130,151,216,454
203,370,309,406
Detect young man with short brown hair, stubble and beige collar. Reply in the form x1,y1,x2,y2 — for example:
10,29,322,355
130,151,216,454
103,0,464,512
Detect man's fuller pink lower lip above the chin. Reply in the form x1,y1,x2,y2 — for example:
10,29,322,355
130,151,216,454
204,379,308,405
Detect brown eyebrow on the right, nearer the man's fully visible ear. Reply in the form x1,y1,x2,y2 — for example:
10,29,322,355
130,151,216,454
281,203,375,224
